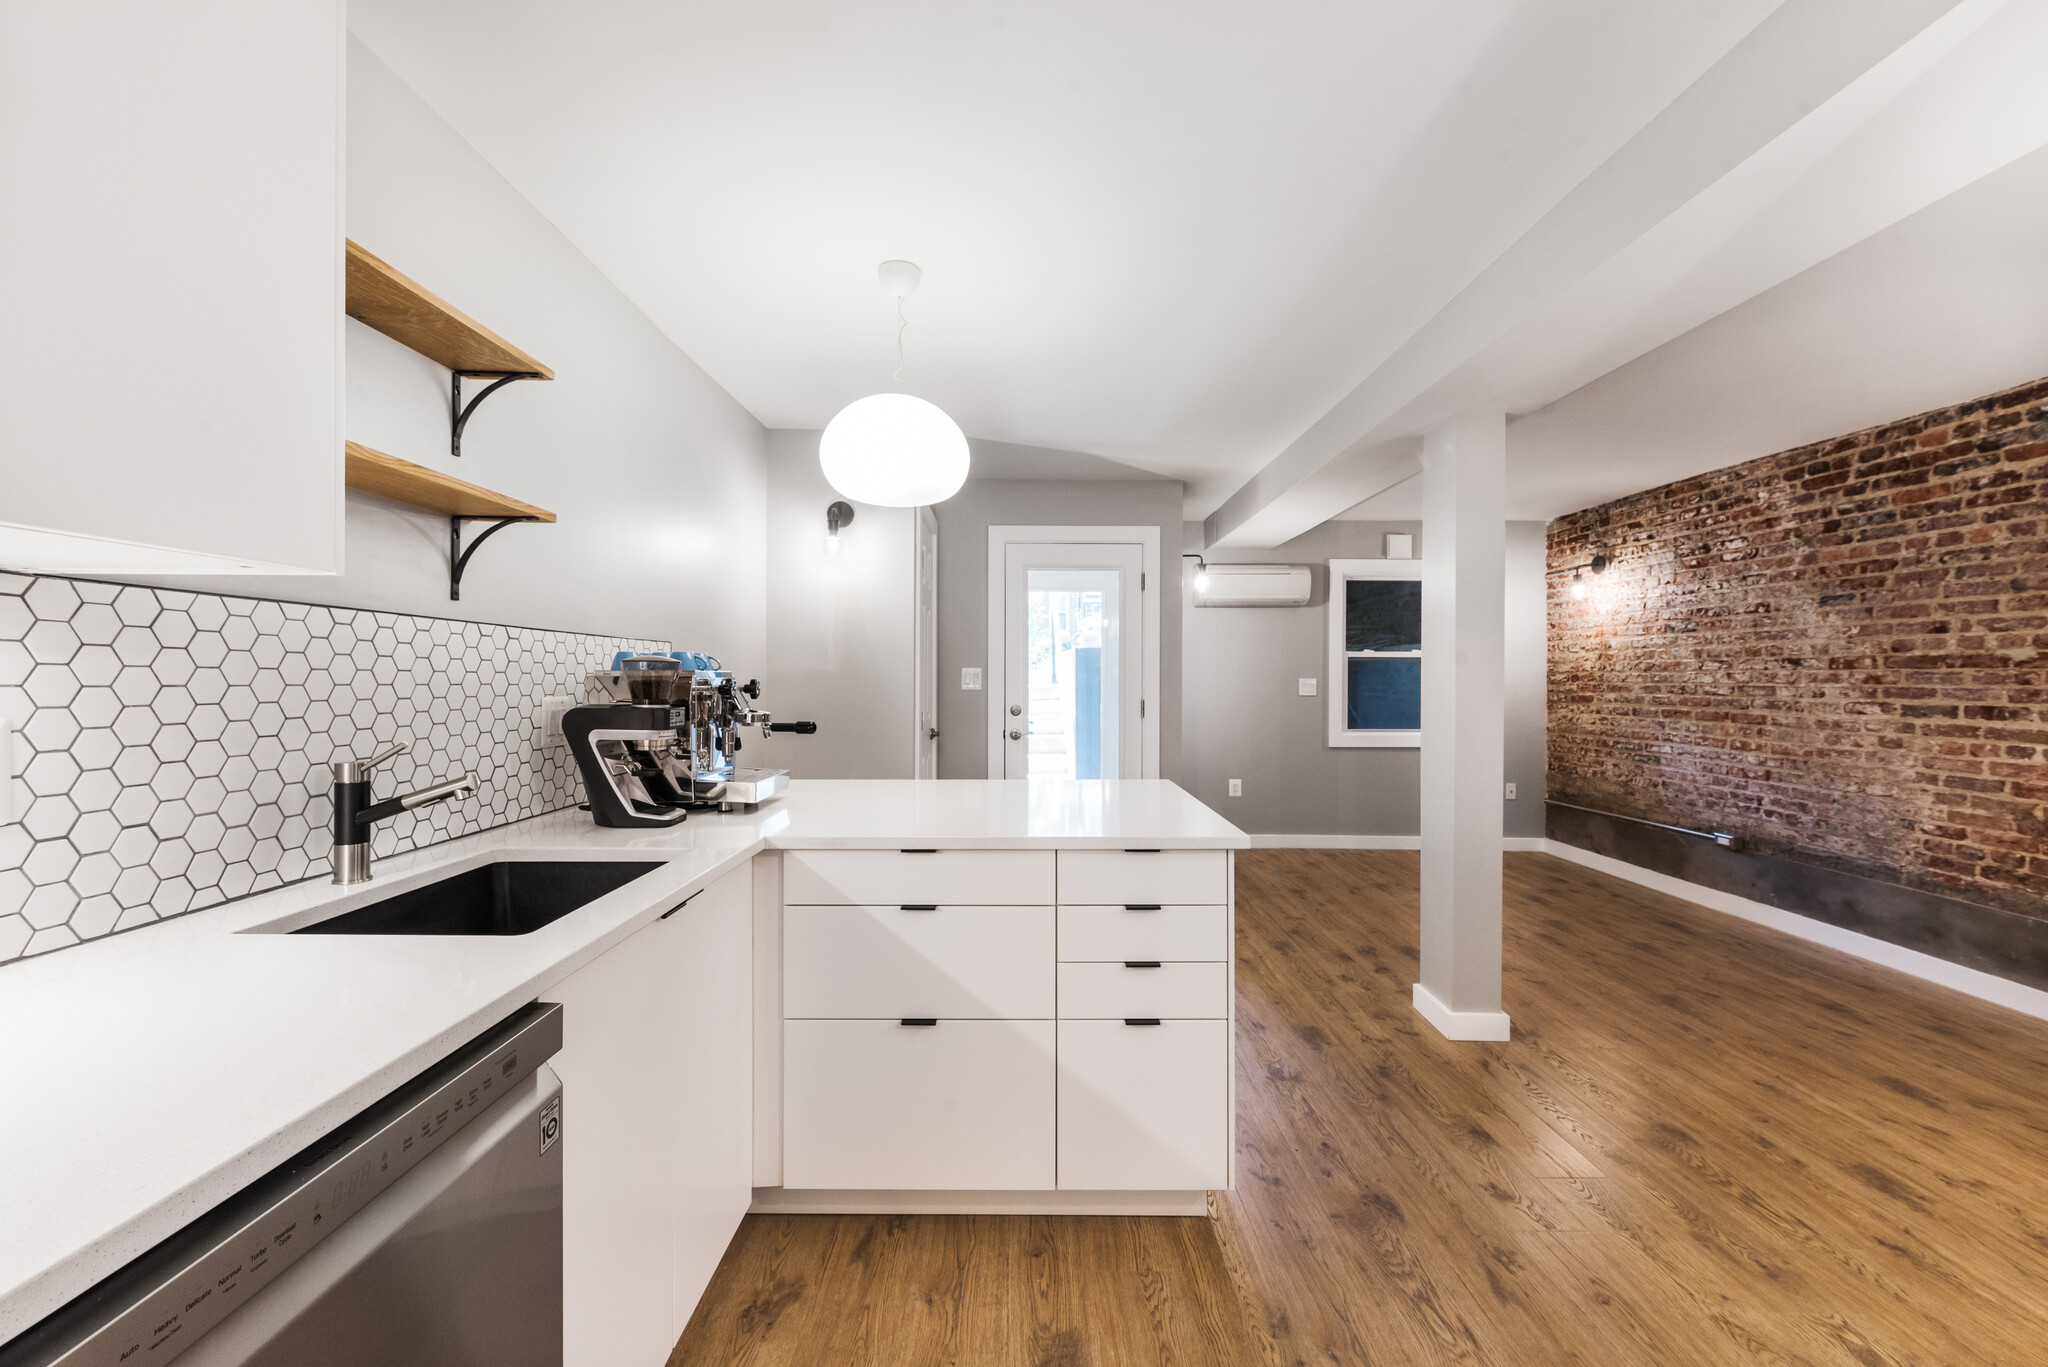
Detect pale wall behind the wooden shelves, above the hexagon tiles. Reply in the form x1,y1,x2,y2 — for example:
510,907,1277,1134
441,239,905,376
142,37,766,670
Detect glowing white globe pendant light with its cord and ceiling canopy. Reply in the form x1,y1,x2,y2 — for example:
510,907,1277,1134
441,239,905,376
817,260,967,508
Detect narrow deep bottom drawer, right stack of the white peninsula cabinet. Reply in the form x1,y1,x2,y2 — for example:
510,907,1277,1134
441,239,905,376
1059,1021,1231,1191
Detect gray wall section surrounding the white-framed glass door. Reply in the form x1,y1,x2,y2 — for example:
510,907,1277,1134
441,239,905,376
934,481,1182,779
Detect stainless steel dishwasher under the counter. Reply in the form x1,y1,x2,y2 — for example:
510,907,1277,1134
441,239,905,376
0,1002,561,1367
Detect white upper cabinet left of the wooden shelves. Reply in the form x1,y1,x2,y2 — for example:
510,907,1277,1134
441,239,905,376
0,0,344,574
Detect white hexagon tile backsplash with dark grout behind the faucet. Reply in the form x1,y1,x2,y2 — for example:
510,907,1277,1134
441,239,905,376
0,574,668,963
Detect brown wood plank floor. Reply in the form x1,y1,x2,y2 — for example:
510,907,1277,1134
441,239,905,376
670,851,2048,1367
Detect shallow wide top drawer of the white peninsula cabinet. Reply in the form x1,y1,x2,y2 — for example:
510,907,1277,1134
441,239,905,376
782,851,1055,906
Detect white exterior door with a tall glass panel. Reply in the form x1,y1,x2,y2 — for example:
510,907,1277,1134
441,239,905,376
999,541,1145,779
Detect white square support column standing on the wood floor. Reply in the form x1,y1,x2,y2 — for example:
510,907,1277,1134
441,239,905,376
1415,412,1507,1039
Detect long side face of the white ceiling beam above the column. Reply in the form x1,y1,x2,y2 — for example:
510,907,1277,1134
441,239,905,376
1206,0,1958,547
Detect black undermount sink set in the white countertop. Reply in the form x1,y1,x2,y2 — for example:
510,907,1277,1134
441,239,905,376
293,859,662,935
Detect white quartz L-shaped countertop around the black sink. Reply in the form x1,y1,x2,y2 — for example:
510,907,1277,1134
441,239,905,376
0,779,1249,1342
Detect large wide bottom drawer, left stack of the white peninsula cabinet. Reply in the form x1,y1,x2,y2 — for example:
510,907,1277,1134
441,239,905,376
782,1019,1055,1191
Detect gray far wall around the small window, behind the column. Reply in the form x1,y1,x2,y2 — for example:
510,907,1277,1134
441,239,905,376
1180,523,1544,836
